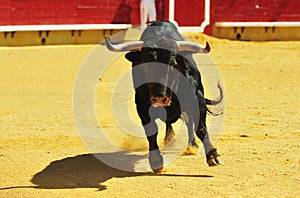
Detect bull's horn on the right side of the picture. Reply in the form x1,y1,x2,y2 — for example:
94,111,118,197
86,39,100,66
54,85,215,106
176,41,210,53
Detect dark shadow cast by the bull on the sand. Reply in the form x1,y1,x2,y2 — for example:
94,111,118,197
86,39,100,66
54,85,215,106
31,152,212,190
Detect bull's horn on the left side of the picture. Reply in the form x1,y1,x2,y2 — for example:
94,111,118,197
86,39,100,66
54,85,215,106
105,35,144,52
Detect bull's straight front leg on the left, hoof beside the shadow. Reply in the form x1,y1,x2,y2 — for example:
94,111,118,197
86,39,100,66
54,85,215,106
144,121,163,173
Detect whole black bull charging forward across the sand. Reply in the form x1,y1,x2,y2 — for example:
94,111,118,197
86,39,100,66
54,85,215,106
105,21,223,172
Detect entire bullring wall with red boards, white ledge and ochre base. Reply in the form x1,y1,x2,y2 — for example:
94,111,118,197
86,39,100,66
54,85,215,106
0,0,300,46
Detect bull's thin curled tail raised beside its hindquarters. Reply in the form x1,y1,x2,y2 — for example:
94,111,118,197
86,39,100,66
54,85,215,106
205,82,224,116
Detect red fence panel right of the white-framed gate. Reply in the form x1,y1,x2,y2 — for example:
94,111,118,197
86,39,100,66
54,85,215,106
211,0,300,22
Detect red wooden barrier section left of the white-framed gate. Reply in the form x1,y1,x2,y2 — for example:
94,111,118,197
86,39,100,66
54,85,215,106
0,0,166,25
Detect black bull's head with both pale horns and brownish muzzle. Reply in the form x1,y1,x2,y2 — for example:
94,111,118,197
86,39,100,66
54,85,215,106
105,33,210,106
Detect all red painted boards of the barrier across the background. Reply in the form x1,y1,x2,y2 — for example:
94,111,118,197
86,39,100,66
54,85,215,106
0,0,300,34
